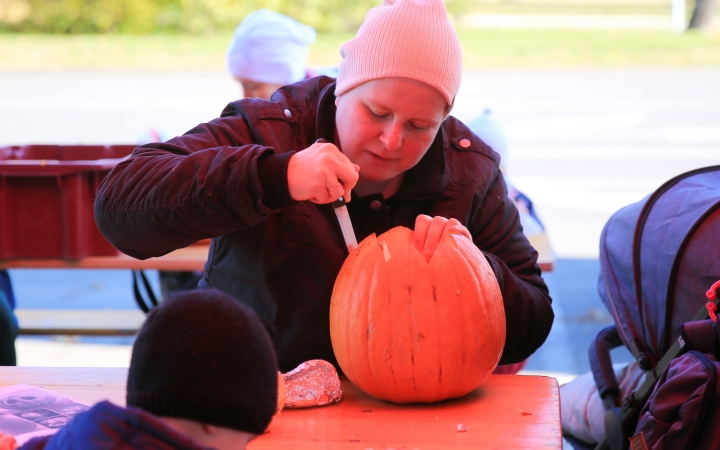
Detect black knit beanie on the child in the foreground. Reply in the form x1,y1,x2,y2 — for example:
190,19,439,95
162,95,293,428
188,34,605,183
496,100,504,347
127,289,278,434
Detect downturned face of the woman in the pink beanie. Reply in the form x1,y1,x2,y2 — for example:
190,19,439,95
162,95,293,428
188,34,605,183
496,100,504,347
335,78,447,190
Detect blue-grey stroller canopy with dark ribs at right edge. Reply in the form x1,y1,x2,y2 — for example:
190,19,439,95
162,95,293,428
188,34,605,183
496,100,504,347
598,166,720,359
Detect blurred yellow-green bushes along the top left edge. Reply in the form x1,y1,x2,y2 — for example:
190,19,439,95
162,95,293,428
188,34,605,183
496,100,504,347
0,0,379,34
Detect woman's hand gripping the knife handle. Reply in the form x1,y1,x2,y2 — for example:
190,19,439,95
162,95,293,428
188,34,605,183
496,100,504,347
288,142,360,204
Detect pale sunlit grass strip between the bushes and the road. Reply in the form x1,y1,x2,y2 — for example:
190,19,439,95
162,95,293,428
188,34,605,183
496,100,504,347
0,29,720,70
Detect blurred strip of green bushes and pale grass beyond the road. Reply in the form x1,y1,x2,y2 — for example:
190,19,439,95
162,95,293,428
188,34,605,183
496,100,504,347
0,0,720,70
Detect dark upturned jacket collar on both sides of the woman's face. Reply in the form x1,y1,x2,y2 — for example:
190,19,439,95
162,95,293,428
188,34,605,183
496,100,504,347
315,79,446,199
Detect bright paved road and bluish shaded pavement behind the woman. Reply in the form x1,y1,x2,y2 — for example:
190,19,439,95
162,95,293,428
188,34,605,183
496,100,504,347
0,69,720,373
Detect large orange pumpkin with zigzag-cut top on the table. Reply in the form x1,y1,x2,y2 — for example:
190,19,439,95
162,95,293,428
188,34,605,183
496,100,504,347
330,227,505,403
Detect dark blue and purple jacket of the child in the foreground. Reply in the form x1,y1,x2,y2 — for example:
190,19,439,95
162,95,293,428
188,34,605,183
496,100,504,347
20,401,210,450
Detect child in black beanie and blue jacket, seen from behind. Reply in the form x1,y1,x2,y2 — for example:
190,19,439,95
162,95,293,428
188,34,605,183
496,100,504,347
0,289,278,450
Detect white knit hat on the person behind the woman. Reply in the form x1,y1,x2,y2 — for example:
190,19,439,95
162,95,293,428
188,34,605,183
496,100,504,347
227,9,315,85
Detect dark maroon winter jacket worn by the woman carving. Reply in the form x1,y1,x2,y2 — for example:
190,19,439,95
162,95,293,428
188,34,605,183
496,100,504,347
95,77,554,372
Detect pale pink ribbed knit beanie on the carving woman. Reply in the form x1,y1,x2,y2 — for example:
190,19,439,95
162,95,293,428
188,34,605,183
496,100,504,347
335,0,462,105
